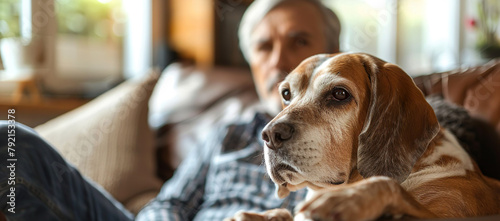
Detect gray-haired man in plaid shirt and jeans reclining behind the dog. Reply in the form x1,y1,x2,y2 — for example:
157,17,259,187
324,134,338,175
0,0,340,220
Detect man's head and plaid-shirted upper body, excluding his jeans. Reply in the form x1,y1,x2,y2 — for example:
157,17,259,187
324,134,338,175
137,0,340,220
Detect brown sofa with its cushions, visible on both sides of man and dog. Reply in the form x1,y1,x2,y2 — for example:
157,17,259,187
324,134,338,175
35,58,500,216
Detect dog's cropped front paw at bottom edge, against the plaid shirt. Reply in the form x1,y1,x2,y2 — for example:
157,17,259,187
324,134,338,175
224,209,293,221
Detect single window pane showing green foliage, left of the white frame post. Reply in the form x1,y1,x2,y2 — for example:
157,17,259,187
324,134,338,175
55,0,125,80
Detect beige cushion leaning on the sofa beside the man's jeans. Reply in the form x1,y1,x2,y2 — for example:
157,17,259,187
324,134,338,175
35,72,162,213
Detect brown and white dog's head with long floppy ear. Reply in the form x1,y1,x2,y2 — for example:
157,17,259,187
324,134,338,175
262,54,439,198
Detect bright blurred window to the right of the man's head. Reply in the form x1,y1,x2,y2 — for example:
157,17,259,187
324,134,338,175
324,0,492,76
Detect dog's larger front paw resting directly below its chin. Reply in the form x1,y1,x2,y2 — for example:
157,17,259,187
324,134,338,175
295,188,385,221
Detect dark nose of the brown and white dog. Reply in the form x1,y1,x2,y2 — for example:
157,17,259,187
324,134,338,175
262,123,294,150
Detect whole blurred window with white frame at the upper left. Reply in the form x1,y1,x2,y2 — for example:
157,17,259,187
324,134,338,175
0,0,152,96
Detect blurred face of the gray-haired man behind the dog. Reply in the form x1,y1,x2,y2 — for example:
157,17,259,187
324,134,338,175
250,1,327,114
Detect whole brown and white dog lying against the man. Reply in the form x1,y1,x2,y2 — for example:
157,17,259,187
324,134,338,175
227,53,500,220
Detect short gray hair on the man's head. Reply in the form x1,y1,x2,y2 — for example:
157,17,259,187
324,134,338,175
238,0,340,62
